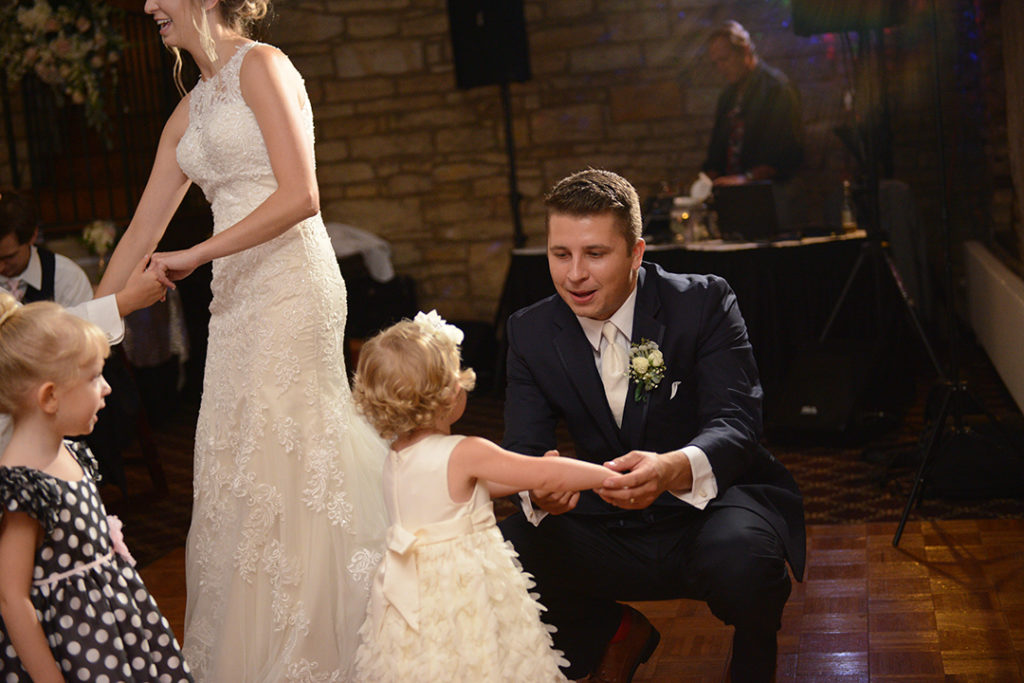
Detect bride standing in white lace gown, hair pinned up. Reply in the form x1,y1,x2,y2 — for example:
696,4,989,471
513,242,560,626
97,0,386,682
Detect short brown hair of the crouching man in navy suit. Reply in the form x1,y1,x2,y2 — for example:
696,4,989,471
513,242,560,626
544,168,643,249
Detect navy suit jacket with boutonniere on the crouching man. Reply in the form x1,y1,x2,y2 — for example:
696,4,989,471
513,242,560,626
503,262,805,579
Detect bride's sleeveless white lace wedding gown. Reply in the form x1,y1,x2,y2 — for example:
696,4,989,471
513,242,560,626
177,43,387,683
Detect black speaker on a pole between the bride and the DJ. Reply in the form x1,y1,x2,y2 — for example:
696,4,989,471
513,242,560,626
447,0,530,89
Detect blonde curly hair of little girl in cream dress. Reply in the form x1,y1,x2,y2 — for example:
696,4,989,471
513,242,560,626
352,321,476,441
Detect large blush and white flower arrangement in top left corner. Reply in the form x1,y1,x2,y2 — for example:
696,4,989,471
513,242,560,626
0,0,125,130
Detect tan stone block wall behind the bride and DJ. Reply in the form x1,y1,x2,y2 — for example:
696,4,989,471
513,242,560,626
0,0,1007,321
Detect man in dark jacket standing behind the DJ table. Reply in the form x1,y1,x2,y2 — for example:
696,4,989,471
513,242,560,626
702,22,804,184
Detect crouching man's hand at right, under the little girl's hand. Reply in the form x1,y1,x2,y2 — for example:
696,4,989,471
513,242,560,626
597,451,693,510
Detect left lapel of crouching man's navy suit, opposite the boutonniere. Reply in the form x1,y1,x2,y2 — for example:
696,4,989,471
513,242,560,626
554,302,629,449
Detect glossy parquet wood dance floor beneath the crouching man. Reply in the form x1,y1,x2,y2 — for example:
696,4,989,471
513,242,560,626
142,519,1024,683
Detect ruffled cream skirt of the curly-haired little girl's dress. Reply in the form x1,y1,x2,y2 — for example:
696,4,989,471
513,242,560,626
356,526,568,683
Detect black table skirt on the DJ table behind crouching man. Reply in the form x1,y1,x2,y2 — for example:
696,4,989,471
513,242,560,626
496,238,880,401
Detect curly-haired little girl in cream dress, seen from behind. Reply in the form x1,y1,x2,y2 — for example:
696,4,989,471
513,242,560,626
353,311,614,683
